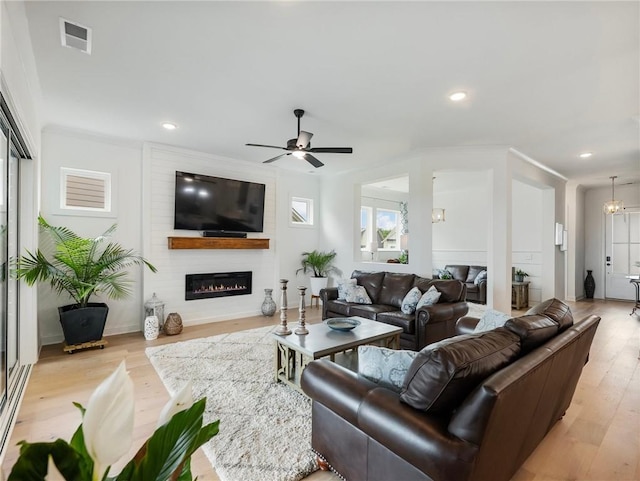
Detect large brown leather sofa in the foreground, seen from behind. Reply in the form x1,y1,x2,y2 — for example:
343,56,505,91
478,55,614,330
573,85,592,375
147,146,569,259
301,299,600,481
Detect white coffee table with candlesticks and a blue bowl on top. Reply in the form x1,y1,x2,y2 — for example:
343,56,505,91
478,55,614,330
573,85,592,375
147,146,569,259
273,316,402,392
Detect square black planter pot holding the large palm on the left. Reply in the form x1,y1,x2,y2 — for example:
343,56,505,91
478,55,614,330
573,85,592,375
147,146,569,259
58,302,109,345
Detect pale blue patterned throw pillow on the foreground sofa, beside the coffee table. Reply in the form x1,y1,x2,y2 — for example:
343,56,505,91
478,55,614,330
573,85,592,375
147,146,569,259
358,346,418,393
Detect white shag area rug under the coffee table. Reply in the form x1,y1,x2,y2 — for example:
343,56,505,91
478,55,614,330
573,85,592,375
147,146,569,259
145,326,317,481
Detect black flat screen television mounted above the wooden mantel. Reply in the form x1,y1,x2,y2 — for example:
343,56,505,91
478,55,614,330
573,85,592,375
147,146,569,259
173,171,265,232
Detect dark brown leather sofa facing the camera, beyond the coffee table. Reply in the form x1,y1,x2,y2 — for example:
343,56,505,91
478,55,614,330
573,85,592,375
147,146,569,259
320,270,469,350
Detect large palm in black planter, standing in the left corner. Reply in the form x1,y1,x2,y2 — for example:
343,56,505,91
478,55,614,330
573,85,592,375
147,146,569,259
15,216,156,352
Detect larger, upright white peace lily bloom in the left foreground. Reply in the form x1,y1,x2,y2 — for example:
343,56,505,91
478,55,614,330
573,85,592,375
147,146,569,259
82,361,134,480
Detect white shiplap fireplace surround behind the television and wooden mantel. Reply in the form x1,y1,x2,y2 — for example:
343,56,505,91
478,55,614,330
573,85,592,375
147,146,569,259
142,144,278,325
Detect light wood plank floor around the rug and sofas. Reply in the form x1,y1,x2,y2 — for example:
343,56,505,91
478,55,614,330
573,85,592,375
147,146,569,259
3,300,640,481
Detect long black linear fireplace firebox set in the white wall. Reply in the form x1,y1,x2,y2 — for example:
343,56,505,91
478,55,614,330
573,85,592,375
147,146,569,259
184,271,252,301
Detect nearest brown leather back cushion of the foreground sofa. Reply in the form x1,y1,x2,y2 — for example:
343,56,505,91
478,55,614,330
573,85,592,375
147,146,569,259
400,327,520,413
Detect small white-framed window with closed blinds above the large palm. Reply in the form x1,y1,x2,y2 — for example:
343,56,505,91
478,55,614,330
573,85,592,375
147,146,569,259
60,167,111,212
